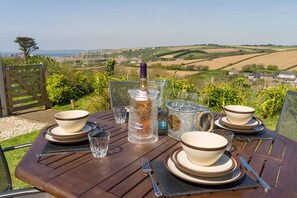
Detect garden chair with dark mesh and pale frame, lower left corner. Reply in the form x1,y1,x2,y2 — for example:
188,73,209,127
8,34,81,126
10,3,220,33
0,143,52,198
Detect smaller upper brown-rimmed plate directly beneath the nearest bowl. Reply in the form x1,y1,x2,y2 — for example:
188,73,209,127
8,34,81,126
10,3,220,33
171,148,237,177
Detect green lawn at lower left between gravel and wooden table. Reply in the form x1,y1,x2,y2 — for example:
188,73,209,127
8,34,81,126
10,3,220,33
0,130,40,189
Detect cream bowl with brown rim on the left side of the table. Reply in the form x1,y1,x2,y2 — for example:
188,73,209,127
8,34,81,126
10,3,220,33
54,110,89,133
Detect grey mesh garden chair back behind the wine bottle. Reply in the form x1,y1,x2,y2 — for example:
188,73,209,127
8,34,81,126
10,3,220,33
108,80,168,108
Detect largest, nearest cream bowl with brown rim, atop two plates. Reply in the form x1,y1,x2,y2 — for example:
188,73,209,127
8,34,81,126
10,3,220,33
180,131,228,166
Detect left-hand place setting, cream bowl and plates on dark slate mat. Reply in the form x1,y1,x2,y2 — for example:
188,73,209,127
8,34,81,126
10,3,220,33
36,110,109,157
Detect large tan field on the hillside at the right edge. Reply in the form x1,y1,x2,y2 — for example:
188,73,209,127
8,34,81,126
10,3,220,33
232,50,297,71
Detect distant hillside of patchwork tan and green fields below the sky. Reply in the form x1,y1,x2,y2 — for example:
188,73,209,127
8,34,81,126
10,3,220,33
71,44,297,71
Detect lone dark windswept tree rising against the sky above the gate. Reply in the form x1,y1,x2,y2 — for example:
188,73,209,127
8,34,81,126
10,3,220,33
14,36,39,60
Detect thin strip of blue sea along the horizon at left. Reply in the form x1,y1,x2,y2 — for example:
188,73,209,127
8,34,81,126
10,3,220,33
0,50,93,57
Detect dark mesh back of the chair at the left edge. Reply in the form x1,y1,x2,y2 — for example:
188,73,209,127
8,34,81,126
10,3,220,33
0,146,12,192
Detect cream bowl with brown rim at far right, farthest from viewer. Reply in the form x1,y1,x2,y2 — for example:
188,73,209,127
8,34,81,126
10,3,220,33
224,105,255,125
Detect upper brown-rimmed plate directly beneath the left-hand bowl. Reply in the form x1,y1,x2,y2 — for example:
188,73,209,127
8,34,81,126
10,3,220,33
46,122,96,139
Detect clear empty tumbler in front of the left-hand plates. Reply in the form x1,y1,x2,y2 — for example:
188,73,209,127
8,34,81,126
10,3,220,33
88,130,110,158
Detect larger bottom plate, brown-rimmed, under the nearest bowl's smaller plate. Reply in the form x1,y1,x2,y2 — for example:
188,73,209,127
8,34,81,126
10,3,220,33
164,155,245,185
